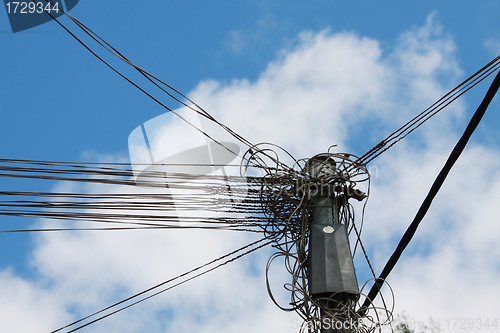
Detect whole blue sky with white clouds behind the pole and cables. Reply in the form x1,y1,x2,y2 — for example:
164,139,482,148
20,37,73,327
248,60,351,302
0,1,500,332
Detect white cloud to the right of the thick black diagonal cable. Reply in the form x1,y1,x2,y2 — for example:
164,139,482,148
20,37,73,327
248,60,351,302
382,147,500,331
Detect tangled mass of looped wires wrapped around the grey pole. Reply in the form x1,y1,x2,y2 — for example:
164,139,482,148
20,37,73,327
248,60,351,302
240,144,394,332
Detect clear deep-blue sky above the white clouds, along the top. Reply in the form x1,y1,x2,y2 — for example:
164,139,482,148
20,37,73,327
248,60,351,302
0,1,500,160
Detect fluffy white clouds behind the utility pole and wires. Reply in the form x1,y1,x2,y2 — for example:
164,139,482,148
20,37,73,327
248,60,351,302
0,16,500,332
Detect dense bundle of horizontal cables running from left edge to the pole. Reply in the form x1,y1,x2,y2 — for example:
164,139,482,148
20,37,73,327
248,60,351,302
0,159,265,233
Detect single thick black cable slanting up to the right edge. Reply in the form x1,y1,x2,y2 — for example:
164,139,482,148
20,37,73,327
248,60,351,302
359,68,500,315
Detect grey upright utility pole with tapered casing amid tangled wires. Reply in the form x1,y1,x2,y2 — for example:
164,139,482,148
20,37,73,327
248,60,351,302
308,155,359,333
